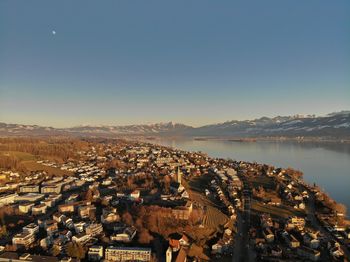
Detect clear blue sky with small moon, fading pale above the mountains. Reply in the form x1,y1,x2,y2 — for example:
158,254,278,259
0,0,350,127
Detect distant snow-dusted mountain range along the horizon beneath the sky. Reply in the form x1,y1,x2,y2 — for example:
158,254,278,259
0,111,350,138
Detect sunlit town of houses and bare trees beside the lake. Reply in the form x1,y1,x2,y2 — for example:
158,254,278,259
0,138,350,262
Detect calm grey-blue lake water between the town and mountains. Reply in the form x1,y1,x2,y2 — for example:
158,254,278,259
152,139,350,211
